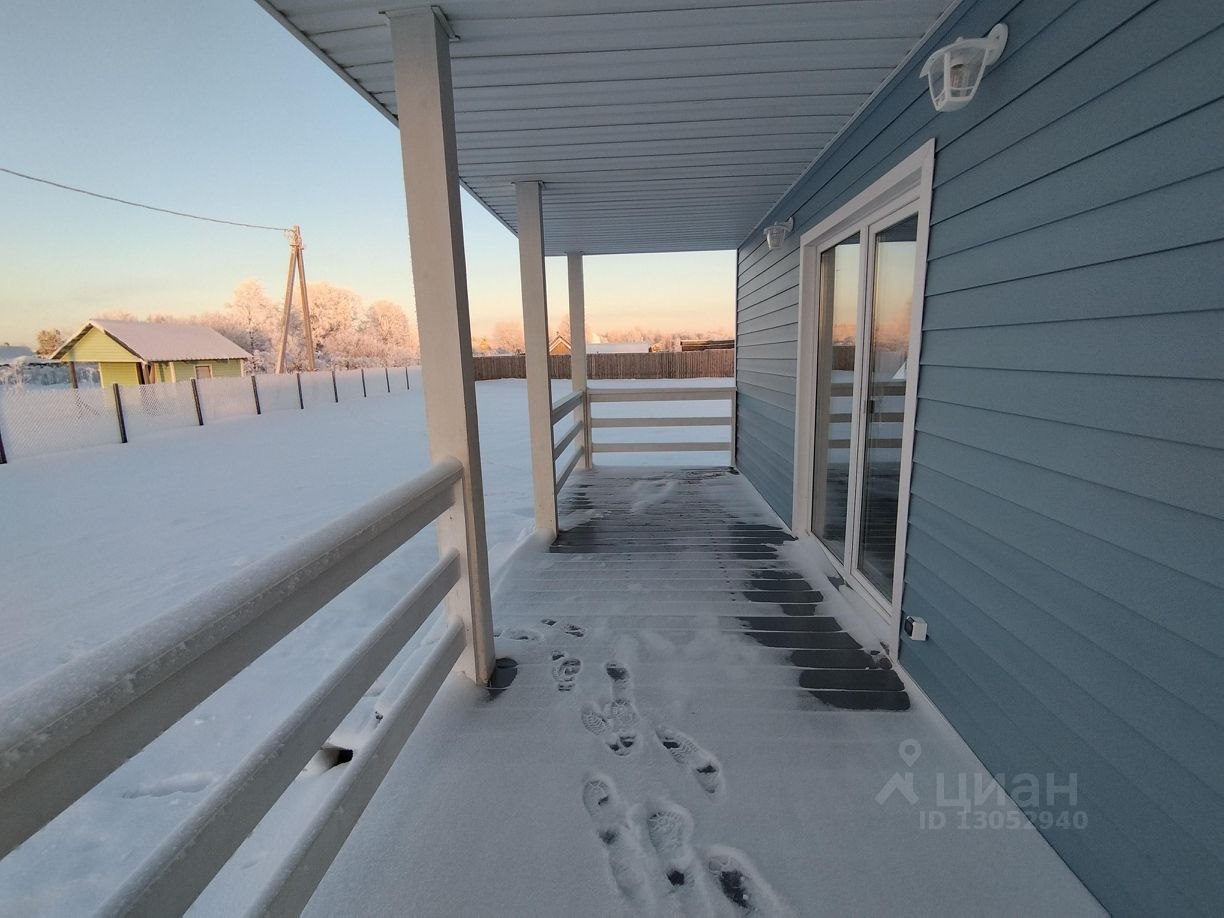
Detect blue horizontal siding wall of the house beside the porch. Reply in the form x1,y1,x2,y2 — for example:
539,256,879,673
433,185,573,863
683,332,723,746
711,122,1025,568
737,0,1224,914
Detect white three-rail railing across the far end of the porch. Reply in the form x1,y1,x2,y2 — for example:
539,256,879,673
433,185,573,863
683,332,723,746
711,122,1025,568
586,386,736,454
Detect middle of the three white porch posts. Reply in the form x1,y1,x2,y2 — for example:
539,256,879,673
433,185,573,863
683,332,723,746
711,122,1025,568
514,181,557,536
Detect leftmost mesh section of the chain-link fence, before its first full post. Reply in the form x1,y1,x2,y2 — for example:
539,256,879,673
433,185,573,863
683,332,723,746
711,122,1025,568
0,388,119,459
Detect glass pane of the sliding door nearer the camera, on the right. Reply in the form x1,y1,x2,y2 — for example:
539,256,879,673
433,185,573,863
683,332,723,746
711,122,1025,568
857,214,918,600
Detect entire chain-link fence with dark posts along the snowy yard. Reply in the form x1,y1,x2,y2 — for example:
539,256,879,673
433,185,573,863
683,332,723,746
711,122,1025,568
0,367,409,463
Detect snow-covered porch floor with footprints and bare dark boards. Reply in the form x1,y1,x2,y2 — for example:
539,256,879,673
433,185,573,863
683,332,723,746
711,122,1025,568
308,469,1099,916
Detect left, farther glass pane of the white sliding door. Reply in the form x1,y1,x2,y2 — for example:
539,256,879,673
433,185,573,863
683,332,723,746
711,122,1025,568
812,233,860,558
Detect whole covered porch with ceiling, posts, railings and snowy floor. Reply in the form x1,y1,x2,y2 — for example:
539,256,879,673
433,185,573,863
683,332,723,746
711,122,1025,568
0,0,1150,916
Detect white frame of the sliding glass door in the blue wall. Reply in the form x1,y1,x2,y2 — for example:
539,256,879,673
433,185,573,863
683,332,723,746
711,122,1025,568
791,140,935,641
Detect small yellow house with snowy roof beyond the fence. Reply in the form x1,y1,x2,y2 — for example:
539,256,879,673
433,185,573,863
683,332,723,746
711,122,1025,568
53,318,251,386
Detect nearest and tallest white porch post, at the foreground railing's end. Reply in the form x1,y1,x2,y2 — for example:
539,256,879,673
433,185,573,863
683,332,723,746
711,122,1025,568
387,7,494,684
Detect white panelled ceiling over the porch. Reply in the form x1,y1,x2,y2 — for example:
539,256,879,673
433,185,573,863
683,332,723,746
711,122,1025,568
257,0,950,255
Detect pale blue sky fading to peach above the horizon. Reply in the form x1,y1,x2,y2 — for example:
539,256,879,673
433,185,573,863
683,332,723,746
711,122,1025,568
0,0,734,344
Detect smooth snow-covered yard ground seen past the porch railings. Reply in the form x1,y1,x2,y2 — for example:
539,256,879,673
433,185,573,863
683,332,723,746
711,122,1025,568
0,377,727,914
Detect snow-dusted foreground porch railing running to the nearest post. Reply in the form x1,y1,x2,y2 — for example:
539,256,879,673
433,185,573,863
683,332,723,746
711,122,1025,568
0,459,488,914
